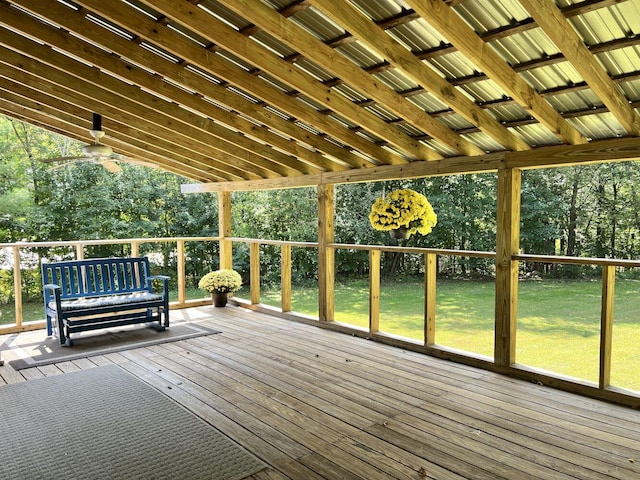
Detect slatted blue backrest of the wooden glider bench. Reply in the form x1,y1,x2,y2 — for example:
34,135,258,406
42,257,150,299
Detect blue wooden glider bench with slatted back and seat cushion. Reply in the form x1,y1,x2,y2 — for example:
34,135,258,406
42,257,169,347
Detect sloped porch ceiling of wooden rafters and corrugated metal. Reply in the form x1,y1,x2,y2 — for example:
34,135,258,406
0,0,640,185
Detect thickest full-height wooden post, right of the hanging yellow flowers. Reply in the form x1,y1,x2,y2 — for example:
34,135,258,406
494,168,522,367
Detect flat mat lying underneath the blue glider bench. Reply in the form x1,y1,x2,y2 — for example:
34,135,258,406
0,322,220,370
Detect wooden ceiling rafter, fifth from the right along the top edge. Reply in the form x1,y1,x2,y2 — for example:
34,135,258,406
141,0,441,160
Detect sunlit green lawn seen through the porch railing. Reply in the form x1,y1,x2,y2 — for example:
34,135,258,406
5,279,640,391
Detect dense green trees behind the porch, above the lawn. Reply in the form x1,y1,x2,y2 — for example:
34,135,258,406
6,117,640,296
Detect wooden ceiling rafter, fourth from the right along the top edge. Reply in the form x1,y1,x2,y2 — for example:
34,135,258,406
220,0,482,155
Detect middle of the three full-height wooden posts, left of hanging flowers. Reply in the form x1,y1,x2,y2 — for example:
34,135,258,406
318,184,335,322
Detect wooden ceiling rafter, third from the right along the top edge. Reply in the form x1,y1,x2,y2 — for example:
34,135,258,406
308,0,531,155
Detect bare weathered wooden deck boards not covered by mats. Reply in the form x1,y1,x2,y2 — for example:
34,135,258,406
0,307,640,480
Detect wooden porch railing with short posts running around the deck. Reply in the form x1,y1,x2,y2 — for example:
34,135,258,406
0,237,640,407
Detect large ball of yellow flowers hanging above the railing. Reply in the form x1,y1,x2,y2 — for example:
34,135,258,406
369,188,438,239
